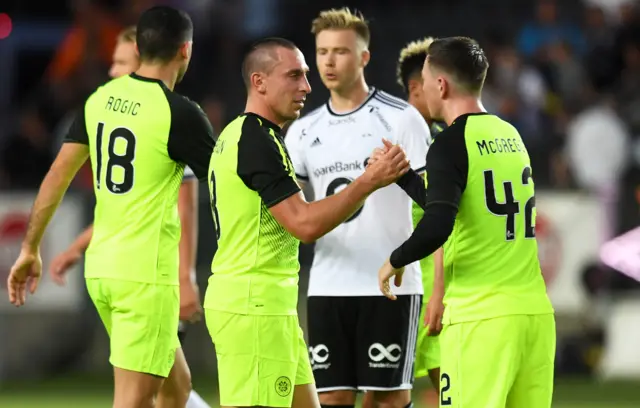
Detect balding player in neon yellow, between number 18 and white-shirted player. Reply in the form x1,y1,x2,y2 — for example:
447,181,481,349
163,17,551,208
204,38,409,408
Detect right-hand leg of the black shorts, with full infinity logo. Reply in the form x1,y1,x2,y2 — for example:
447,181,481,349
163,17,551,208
356,295,422,391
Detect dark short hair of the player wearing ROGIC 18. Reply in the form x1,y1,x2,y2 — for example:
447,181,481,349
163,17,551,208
136,6,193,62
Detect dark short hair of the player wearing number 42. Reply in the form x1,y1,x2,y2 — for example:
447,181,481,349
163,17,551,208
427,37,489,93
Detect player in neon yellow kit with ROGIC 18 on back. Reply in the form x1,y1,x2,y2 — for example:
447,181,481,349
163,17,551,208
8,7,213,408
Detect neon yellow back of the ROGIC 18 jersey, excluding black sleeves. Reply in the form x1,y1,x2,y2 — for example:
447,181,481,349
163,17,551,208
84,74,189,285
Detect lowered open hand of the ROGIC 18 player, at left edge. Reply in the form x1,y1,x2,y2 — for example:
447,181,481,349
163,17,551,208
7,249,42,306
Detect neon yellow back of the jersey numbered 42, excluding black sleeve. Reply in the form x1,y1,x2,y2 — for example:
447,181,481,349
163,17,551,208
442,114,553,323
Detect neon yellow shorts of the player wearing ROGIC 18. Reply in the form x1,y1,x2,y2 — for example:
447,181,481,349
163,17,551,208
86,278,180,377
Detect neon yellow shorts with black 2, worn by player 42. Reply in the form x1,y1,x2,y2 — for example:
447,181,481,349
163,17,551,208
440,314,556,408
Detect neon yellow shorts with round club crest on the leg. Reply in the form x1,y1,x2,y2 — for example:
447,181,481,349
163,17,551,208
205,309,314,407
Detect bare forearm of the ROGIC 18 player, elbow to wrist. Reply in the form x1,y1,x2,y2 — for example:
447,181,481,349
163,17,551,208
22,168,71,251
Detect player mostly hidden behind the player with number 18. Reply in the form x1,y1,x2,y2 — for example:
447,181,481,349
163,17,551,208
49,26,209,408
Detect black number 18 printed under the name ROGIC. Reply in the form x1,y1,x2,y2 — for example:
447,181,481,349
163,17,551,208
96,122,136,194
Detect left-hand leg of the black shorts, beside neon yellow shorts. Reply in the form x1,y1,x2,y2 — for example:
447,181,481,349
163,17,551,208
307,296,358,393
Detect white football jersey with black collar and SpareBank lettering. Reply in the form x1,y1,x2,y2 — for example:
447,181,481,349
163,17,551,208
285,89,431,296
